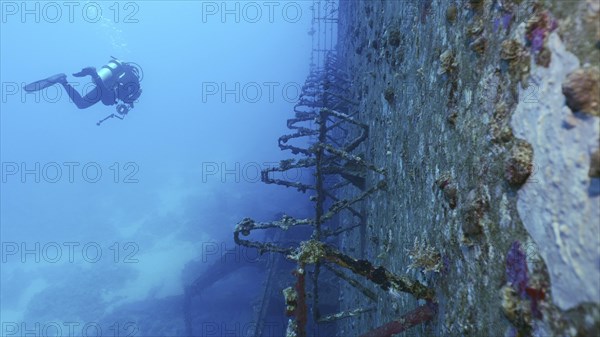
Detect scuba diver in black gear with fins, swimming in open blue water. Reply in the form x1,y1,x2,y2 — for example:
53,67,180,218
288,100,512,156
23,56,142,125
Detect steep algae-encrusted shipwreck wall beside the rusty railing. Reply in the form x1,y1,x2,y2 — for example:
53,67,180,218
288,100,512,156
338,0,600,336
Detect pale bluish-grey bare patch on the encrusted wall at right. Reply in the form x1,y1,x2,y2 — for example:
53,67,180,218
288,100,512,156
511,32,600,310
